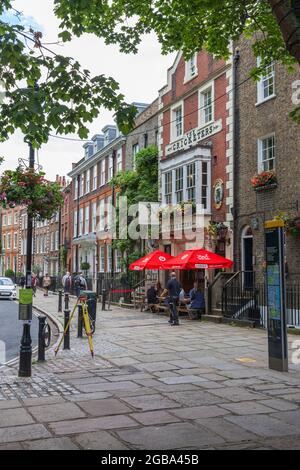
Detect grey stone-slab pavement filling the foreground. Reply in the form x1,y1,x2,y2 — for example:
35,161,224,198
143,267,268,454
0,294,300,450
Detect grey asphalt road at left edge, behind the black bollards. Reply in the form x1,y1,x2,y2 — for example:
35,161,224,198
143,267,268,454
0,300,38,365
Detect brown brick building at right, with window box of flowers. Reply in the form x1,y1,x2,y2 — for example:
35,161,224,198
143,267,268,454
234,40,300,282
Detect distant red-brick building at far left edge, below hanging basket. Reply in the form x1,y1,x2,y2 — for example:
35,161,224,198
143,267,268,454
1,206,22,275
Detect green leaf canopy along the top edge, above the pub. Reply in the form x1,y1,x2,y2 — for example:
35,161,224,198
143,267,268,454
55,0,300,62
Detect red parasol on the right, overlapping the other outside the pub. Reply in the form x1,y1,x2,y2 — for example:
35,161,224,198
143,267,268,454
164,248,233,269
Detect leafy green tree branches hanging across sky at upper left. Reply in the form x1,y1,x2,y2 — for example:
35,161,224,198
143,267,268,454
0,1,136,148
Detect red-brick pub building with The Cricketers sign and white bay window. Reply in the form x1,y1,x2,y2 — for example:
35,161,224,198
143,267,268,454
159,51,233,281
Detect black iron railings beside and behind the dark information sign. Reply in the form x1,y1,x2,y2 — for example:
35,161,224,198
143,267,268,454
222,272,300,327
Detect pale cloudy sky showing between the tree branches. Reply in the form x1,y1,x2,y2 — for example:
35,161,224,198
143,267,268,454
0,0,175,179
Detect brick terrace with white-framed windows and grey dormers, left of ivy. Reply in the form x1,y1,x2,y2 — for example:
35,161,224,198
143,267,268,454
69,125,125,287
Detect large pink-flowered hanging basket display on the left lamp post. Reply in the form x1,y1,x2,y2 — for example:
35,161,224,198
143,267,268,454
0,167,63,220
